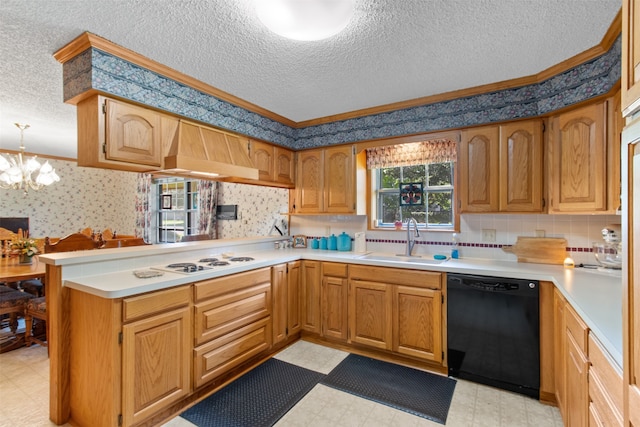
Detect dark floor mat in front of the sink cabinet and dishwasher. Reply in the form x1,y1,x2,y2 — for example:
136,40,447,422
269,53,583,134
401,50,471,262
321,354,456,424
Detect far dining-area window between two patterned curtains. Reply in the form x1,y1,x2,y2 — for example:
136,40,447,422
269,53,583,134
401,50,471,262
156,178,198,243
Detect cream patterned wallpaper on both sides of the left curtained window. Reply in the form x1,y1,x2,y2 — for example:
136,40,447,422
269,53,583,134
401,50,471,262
0,160,289,239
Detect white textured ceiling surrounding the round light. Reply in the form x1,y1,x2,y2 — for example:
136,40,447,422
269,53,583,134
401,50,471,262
0,0,621,157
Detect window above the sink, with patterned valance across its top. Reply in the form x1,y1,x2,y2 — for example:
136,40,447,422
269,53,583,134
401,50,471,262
367,139,458,231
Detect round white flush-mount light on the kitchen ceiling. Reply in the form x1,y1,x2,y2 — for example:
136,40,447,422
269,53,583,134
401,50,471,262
255,0,355,41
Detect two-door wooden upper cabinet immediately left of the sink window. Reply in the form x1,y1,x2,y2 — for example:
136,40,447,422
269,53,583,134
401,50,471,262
294,145,356,213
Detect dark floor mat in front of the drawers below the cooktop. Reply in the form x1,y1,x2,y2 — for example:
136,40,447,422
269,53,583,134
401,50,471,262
180,359,325,427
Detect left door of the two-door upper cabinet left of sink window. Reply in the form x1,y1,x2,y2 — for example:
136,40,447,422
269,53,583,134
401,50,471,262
295,150,324,213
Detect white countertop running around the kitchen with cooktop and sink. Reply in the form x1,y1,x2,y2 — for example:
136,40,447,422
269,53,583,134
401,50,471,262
48,239,622,366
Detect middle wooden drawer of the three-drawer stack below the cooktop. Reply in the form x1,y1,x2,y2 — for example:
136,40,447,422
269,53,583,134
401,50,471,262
194,283,272,344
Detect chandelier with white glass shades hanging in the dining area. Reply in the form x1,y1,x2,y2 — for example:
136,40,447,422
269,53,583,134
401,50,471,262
0,123,60,195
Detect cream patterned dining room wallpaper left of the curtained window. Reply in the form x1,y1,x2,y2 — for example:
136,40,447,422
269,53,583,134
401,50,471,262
0,159,136,237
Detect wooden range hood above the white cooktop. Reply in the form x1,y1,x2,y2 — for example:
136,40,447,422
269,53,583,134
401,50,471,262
159,120,258,180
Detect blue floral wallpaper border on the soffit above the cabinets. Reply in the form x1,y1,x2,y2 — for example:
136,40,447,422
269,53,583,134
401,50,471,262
63,37,622,149
